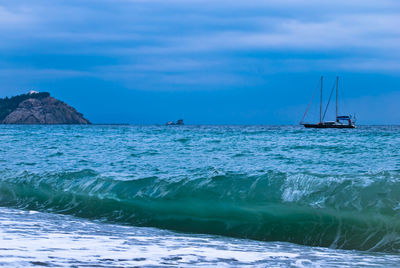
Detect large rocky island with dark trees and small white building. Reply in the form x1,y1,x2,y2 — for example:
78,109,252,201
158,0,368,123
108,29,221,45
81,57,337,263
0,91,90,124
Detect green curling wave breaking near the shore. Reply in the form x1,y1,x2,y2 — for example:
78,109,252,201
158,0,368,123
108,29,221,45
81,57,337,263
0,169,400,252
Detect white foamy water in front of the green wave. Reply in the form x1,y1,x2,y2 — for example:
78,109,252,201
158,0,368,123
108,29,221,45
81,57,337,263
0,208,399,267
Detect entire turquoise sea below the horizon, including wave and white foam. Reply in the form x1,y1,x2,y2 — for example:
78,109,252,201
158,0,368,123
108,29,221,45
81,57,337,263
0,125,400,267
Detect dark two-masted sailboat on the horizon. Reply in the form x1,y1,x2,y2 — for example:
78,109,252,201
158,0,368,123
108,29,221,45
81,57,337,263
300,76,356,128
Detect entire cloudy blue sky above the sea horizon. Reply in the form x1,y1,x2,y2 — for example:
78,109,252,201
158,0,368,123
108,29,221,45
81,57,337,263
0,0,400,124
